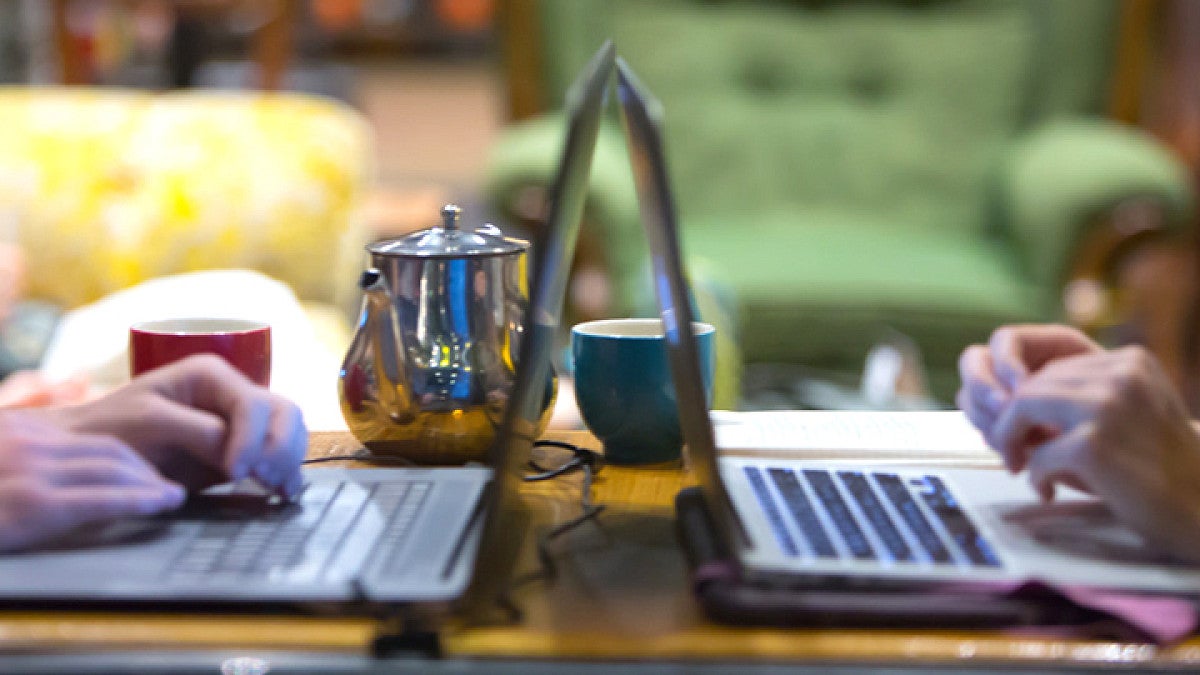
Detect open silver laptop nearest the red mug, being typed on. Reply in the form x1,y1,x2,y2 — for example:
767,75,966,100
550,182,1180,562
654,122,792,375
0,43,613,607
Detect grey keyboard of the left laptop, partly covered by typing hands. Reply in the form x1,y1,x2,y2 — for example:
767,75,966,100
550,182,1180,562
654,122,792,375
166,480,431,583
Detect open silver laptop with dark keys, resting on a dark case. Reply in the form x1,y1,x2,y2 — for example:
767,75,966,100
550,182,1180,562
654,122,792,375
617,59,1200,592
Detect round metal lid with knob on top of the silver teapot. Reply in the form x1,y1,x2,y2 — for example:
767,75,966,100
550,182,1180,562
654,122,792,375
367,204,529,258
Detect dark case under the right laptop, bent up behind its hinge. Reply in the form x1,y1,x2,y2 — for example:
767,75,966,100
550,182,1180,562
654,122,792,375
676,488,1100,628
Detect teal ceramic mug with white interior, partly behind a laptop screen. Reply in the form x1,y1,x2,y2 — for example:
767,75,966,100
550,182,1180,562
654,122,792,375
571,318,715,464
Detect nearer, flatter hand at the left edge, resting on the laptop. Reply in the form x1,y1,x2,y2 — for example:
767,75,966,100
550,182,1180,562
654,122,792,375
0,411,184,551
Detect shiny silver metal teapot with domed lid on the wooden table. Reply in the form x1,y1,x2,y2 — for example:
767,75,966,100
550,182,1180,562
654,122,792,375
338,205,556,464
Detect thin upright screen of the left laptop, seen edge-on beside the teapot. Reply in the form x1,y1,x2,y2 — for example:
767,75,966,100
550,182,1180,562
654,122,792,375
456,41,616,603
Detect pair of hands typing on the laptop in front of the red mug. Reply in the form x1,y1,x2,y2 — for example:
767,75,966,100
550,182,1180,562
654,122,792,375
0,356,307,551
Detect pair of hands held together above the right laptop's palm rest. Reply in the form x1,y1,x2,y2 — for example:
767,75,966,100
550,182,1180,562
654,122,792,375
958,325,1200,562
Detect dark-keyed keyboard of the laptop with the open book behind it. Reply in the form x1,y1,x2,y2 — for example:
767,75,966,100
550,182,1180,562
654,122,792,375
744,466,1001,568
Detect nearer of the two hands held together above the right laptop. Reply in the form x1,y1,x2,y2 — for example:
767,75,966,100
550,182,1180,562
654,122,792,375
992,347,1200,562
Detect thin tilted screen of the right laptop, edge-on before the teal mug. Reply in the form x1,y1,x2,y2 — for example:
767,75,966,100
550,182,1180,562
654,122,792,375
617,59,740,542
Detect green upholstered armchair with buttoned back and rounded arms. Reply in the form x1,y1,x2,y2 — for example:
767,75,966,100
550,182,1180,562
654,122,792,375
487,0,1194,400
